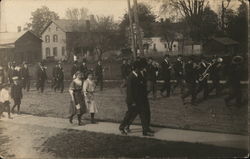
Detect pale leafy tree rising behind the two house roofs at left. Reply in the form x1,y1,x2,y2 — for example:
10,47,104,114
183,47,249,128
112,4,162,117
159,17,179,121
26,6,59,36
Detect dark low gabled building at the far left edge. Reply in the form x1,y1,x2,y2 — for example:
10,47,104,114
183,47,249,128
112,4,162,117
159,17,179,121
0,31,42,64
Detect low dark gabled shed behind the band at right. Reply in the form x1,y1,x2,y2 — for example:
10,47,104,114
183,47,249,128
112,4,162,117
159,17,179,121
203,37,239,55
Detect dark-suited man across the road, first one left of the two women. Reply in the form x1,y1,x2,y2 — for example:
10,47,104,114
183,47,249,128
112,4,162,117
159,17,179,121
55,61,64,93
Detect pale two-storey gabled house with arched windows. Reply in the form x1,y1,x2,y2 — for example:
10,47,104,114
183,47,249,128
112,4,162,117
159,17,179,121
42,19,90,60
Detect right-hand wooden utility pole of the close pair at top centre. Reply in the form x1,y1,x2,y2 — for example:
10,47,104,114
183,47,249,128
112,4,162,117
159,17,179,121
134,0,144,56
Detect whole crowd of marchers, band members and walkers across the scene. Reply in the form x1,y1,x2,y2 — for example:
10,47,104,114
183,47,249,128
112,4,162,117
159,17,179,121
0,55,246,136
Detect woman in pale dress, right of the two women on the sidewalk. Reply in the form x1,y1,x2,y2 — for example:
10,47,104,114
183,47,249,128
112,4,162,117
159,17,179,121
83,72,98,124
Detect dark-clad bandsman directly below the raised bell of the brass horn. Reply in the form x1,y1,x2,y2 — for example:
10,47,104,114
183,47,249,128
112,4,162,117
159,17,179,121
209,58,223,95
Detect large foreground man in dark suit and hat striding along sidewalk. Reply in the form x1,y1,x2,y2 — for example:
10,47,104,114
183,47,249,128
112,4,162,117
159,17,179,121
119,61,153,136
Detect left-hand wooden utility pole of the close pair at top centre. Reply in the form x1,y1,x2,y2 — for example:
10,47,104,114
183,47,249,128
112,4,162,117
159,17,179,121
128,0,137,60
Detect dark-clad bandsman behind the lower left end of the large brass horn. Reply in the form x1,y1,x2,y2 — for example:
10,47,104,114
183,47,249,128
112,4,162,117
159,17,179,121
196,57,208,100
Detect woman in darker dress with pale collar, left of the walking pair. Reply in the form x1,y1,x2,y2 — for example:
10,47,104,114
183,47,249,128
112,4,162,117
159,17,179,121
69,71,86,125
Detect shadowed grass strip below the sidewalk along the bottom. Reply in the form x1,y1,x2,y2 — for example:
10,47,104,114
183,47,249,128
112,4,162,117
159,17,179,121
43,130,247,158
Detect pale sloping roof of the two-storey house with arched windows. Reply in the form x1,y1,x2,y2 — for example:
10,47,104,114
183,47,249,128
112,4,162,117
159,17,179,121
41,19,88,34
